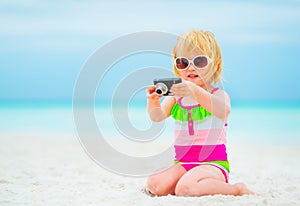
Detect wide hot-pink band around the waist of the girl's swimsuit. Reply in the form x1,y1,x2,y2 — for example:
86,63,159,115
174,144,227,162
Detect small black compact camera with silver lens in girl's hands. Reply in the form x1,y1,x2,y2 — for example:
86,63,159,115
153,78,182,96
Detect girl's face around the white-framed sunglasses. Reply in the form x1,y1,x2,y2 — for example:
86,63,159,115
178,50,211,87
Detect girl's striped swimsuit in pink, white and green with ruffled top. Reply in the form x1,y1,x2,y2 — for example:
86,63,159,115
171,88,229,182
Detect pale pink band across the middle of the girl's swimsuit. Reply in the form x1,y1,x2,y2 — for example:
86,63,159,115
174,128,226,146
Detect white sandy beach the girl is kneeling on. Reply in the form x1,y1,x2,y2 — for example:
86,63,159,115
0,133,300,206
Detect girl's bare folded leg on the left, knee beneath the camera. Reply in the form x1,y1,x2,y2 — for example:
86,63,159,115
147,164,186,196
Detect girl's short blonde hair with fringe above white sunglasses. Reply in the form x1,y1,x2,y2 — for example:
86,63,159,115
173,30,222,83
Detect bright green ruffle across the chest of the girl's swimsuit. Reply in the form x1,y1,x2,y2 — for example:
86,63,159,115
171,102,211,122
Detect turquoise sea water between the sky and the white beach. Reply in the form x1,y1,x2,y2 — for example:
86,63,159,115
0,101,300,144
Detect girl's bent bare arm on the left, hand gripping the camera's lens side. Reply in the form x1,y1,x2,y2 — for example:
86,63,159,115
147,86,176,122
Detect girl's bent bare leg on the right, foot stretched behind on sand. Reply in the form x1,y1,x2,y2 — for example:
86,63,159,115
175,165,254,196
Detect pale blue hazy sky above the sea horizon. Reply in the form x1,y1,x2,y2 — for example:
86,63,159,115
0,0,300,102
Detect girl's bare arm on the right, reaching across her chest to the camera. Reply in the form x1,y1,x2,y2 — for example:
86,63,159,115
171,81,230,122
